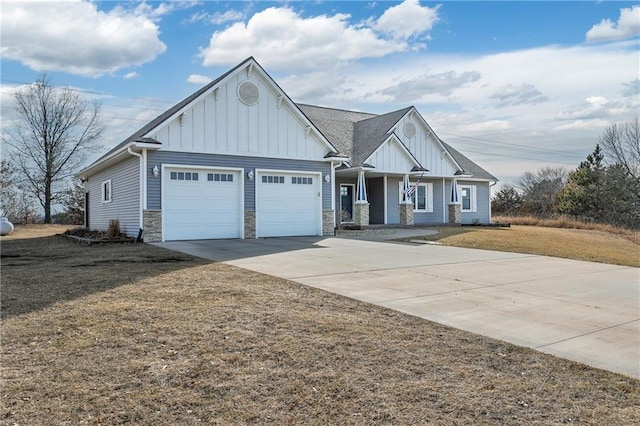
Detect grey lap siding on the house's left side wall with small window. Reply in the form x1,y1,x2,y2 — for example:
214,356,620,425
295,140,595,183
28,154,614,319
86,156,140,236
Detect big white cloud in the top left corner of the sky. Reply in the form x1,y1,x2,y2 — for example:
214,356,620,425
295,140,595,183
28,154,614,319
0,0,166,76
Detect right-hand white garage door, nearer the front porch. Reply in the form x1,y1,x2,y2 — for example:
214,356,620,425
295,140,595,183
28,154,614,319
256,171,322,237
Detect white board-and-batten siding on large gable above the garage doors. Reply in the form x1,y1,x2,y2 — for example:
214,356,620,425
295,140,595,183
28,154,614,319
149,71,328,160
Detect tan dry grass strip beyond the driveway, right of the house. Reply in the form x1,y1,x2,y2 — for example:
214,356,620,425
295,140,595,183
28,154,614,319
412,225,640,267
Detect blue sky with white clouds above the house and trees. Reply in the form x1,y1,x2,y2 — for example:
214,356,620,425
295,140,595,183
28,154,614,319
0,0,640,186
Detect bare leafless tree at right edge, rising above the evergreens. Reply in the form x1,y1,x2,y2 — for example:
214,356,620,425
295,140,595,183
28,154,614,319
600,118,640,188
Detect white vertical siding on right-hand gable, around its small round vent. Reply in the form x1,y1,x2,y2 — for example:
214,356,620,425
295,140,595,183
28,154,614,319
396,116,457,176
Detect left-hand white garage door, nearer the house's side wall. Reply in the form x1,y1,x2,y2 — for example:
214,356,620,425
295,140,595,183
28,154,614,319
162,167,242,241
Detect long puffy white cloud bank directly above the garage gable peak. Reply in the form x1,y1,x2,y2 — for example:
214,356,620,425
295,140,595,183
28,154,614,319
199,0,437,71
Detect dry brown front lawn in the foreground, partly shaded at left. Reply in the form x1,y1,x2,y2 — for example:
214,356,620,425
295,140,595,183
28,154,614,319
0,226,640,425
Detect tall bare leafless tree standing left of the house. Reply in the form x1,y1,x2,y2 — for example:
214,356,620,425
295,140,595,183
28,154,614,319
2,74,104,223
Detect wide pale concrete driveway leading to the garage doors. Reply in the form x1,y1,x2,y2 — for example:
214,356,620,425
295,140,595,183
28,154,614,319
158,237,640,378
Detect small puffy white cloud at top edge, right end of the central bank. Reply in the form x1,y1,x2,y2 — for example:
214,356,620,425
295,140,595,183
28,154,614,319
373,0,440,39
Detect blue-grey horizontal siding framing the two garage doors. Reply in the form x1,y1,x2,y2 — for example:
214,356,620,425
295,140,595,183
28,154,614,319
147,151,331,210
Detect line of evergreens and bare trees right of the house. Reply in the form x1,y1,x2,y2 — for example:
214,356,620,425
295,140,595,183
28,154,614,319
491,118,640,229
